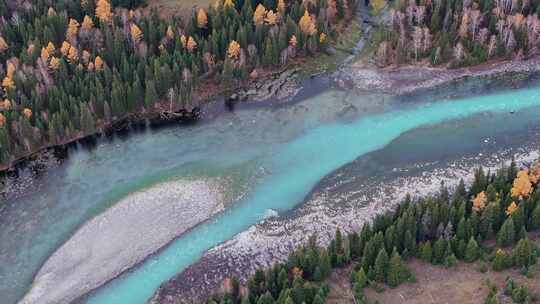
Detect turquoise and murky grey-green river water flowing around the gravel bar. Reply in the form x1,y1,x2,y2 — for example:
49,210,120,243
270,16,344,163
0,73,540,304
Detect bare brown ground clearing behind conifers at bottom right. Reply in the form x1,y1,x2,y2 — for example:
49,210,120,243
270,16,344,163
327,237,540,304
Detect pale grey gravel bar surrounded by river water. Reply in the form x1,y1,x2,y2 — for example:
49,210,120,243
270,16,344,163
19,180,224,304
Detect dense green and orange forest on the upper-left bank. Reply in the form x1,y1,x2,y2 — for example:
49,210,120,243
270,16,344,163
0,0,355,164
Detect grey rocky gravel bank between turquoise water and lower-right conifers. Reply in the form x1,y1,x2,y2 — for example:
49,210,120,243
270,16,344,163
150,142,539,304
